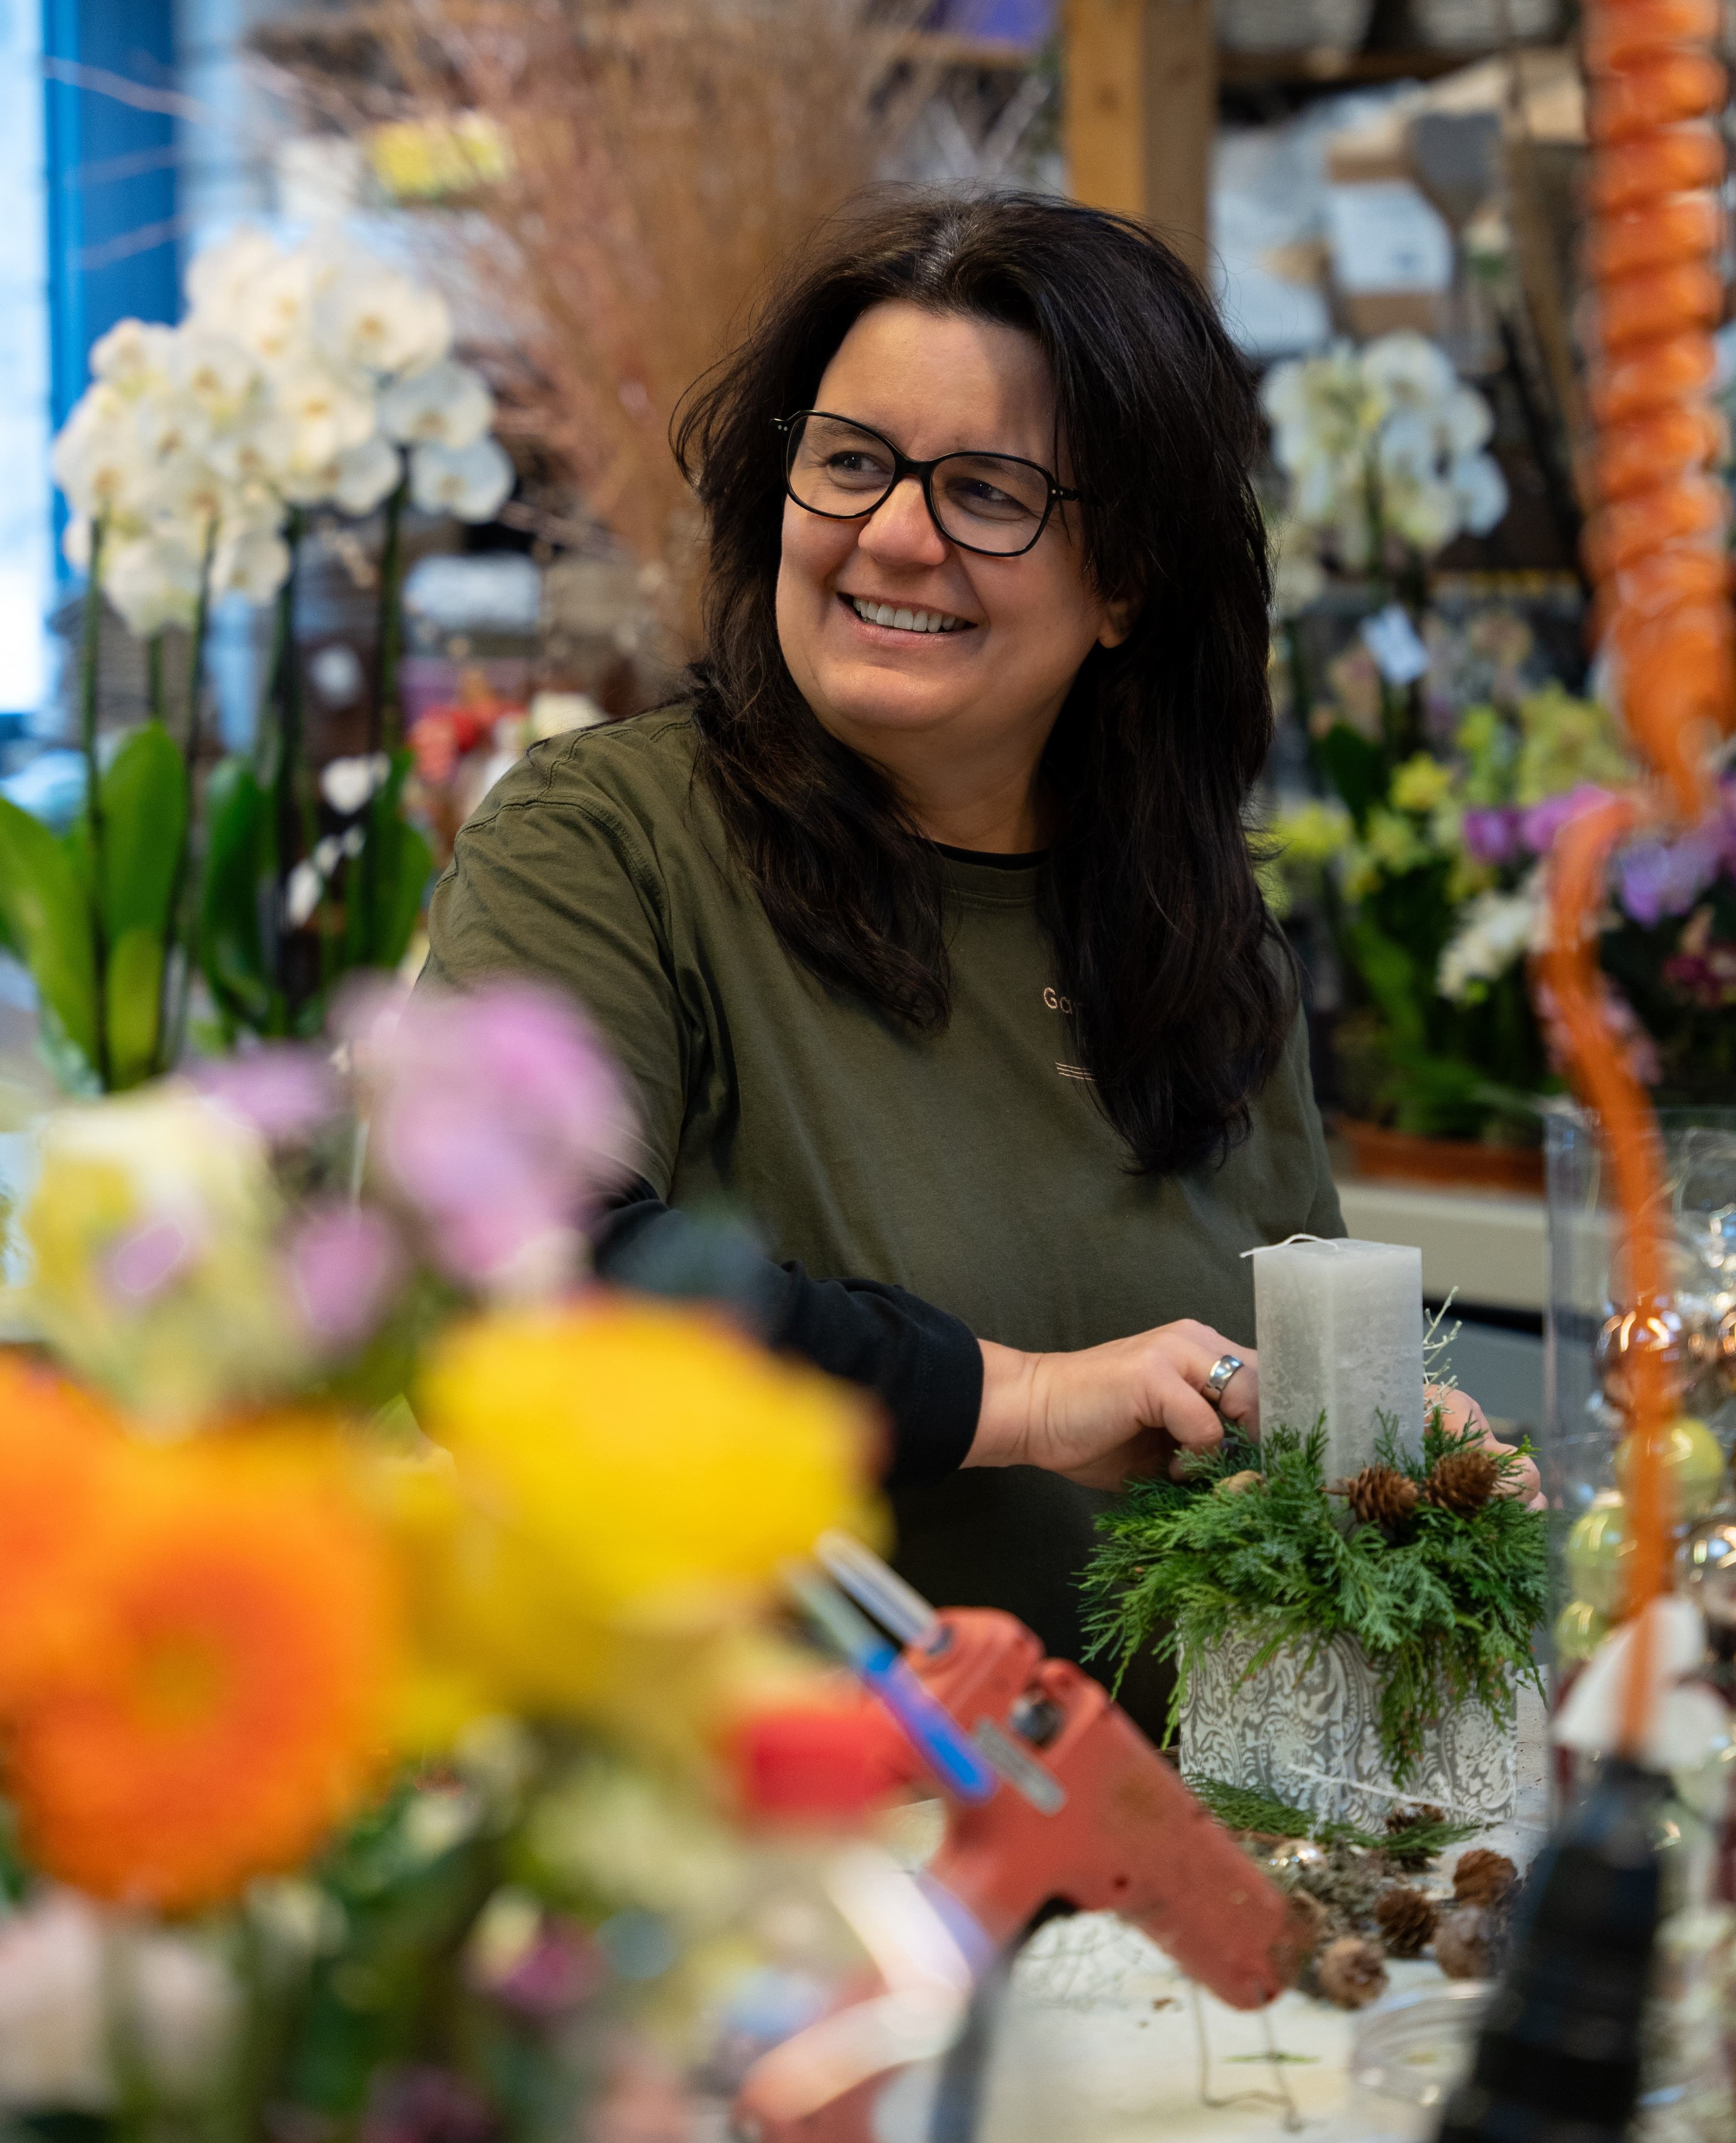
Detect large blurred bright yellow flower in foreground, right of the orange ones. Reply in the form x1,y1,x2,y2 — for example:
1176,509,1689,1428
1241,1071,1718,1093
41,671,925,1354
390,1294,879,1734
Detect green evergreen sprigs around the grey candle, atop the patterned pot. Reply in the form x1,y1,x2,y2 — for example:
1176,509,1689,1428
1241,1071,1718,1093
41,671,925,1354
1085,1410,1547,1787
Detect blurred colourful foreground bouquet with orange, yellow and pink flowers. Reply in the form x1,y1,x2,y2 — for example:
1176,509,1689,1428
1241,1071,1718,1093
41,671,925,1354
0,986,874,2143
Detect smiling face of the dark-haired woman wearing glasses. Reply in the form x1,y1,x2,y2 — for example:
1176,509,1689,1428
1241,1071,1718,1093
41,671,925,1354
778,300,1125,793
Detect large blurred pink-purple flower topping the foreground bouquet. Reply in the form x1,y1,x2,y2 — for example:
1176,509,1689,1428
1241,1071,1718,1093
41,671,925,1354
354,981,632,1288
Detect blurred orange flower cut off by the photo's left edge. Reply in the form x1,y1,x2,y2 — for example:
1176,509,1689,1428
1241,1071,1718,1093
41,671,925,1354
0,1350,120,1708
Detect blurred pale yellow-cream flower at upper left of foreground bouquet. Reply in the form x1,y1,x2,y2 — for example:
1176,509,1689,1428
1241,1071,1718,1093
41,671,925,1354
19,1080,304,1421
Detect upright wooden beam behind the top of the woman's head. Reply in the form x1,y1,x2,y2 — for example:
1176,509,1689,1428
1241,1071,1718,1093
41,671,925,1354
1063,0,1217,270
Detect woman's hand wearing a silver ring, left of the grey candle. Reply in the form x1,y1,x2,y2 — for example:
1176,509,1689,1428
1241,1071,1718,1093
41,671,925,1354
964,1318,1260,1487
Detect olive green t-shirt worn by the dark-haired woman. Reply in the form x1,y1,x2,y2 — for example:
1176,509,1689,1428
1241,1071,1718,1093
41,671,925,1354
429,710,1344,1697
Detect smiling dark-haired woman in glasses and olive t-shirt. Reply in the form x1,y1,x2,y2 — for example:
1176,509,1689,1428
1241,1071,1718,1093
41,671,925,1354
429,195,1491,1714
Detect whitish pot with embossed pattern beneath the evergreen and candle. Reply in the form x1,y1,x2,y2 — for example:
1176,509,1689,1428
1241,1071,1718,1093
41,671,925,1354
1181,1637,1517,1830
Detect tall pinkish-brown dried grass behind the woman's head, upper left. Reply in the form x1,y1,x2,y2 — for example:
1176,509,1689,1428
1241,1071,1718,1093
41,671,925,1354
321,0,932,632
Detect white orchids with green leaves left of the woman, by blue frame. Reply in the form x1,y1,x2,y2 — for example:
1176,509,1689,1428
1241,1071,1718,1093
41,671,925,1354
0,229,512,1091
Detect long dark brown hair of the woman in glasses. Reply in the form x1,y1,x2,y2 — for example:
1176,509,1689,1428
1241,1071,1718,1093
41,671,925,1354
675,191,1294,1172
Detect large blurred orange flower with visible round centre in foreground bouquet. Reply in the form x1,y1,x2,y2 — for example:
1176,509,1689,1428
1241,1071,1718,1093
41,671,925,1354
9,1440,396,1909
